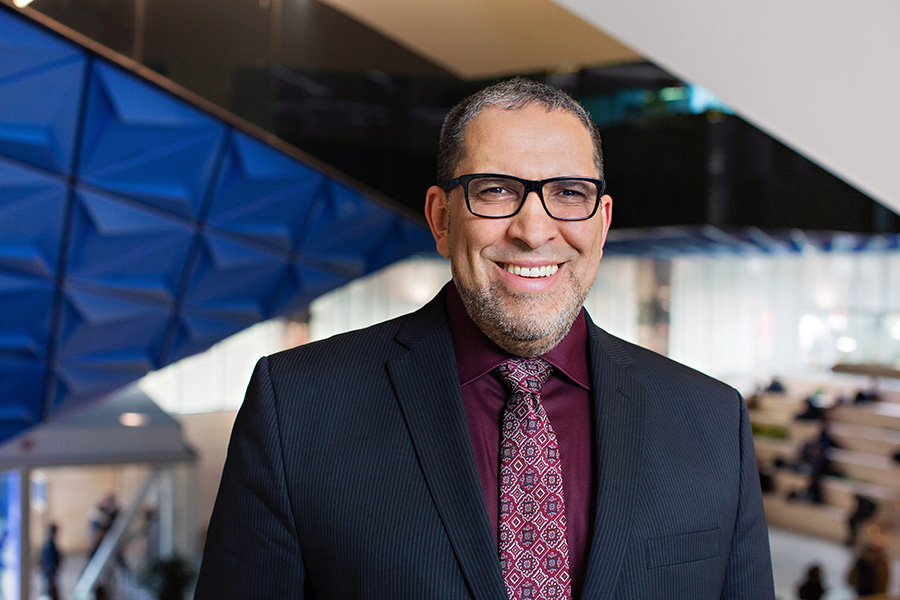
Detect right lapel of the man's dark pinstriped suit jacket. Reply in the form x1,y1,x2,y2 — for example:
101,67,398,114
582,323,646,600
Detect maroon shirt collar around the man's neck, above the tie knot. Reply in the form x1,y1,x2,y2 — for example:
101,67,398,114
445,281,590,390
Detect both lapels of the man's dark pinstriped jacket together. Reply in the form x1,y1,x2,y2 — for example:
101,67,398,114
387,293,646,600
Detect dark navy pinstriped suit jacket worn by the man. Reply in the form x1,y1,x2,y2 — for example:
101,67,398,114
195,294,774,600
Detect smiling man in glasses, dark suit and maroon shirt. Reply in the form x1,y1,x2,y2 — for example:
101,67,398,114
196,79,774,600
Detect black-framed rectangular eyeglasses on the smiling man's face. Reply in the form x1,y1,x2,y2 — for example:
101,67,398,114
441,173,606,221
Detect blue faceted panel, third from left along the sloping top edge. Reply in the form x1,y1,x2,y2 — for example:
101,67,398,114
207,132,326,252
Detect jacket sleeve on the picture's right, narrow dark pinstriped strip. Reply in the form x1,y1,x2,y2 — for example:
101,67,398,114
721,395,775,600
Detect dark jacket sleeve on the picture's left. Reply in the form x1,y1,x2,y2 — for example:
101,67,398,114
194,358,311,600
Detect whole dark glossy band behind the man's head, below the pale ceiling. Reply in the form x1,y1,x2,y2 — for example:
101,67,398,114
15,0,900,234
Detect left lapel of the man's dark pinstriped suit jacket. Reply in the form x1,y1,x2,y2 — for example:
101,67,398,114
387,294,506,600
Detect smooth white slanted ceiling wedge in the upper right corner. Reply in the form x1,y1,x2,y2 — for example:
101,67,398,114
558,0,900,214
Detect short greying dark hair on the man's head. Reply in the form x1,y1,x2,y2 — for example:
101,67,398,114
437,77,603,184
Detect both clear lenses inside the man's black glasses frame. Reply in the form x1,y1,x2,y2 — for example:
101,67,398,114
467,177,598,219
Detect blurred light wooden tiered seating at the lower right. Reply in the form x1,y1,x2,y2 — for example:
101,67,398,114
750,378,900,556
